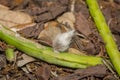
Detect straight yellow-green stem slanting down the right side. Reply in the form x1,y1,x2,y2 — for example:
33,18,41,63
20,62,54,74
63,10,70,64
86,0,120,76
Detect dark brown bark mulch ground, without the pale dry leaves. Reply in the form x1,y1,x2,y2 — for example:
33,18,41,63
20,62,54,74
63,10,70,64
0,0,120,80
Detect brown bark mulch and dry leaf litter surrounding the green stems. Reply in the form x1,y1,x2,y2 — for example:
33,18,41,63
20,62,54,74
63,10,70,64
0,0,120,80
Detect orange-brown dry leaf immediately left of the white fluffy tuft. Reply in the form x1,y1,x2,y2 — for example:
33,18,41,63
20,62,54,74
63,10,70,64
38,21,61,45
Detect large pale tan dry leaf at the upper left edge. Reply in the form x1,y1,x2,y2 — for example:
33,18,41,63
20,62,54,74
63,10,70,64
0,8,32,28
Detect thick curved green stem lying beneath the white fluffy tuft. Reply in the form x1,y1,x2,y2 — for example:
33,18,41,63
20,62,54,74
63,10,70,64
0,25,103,68
